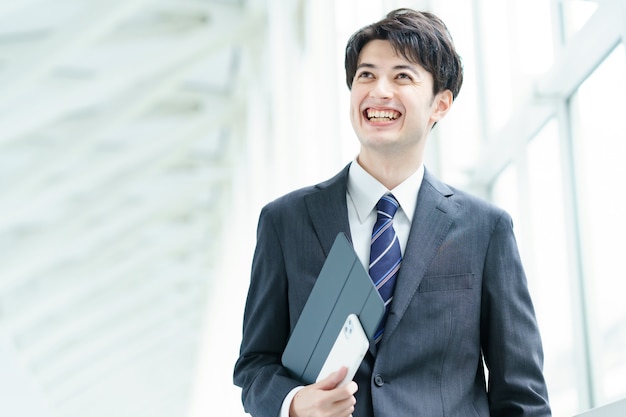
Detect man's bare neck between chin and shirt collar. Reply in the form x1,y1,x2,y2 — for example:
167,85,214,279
357,149,423,190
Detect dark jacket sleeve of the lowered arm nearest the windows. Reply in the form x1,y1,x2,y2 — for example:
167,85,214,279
481,213,551,417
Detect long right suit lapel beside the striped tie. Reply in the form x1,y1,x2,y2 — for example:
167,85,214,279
383,171,458,340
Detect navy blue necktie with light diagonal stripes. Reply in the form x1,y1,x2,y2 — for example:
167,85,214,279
369,194,402,343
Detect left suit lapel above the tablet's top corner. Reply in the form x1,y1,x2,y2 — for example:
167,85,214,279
305,165,352,256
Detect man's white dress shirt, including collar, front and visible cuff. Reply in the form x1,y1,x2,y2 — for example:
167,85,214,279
280,159,424,417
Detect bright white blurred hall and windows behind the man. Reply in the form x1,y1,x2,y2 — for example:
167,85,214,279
0,0,626,417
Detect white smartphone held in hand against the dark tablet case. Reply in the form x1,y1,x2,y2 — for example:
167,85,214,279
315,314,369,386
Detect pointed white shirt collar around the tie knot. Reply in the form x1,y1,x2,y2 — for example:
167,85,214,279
348,159,424,222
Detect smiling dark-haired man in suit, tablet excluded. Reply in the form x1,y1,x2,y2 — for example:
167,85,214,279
234,9,550,417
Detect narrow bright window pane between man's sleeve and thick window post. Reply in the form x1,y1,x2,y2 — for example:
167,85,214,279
526,120,580,416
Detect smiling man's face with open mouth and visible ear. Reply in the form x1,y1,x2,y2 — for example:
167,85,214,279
350,40,451,158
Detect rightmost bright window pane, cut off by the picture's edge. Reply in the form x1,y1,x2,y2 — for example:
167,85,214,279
572,45,626,405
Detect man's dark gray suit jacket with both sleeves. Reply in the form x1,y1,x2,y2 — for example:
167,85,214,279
234,167,550,417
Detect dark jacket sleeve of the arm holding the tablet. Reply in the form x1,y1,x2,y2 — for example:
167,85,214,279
234,207,299,417
